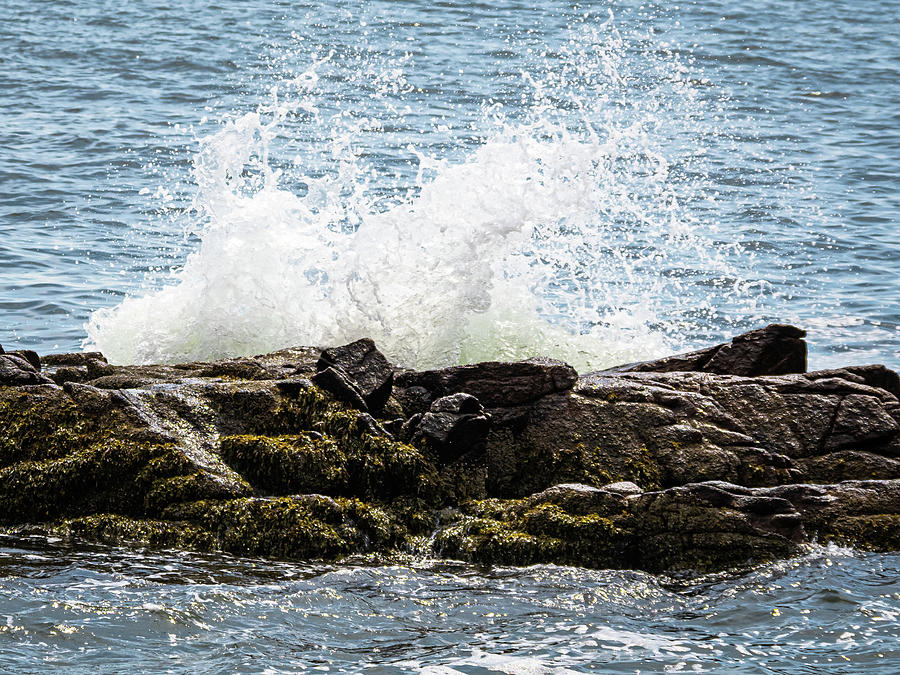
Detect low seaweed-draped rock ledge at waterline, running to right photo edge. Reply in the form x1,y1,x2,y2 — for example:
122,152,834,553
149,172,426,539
437,480,900,571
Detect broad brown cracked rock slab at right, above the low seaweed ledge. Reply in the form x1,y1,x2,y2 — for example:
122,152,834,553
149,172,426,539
485,370,900,498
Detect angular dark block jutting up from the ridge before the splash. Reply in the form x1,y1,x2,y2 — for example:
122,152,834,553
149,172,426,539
316,338,394,415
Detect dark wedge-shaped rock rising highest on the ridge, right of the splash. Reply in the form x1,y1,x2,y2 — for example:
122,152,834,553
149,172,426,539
602,324,806,377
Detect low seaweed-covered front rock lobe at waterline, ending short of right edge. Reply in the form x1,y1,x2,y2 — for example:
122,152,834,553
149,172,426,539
434,482,808,571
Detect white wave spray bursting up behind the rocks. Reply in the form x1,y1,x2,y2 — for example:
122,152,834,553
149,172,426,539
86,22,744,370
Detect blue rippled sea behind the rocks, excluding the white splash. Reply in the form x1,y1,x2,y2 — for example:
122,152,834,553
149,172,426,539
0,0,900,367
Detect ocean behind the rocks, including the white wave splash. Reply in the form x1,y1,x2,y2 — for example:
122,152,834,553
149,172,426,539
0,0,900,370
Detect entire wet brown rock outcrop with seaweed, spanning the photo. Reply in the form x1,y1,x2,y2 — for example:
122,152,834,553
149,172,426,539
0,326,900,570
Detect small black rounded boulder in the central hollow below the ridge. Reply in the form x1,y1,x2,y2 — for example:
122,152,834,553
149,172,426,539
412,394,491,464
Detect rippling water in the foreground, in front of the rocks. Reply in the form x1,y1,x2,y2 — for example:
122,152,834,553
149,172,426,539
0,539,900,675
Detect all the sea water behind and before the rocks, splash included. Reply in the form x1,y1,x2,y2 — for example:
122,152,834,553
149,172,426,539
0,0,900,675
